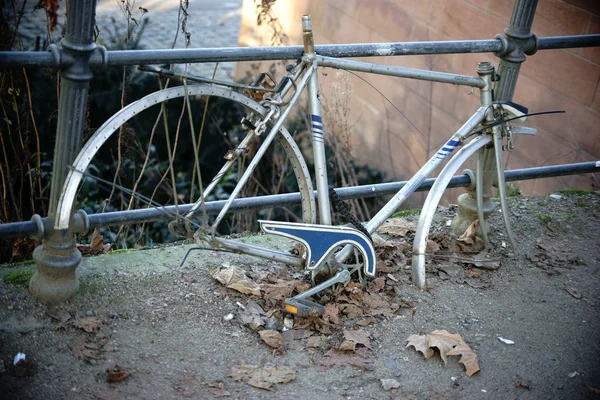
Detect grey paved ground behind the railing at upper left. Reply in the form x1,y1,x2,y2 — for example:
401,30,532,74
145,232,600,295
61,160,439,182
4,0,242,79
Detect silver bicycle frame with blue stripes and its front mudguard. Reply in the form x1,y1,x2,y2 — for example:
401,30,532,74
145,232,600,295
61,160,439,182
55,16,504,287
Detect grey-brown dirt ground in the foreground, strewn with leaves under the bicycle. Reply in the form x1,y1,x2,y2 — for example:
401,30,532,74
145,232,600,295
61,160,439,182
0,193,600,400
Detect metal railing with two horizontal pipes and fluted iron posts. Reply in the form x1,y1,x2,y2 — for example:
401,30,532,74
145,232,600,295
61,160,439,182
0,0,600,302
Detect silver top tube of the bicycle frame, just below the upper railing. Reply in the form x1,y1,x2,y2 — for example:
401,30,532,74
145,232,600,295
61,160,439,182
317,56,486,88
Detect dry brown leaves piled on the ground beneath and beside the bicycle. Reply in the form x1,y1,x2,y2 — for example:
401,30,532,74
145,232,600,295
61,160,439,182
206,218,488,389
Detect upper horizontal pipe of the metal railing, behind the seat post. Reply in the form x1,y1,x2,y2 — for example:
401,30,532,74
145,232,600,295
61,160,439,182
0,35,600,69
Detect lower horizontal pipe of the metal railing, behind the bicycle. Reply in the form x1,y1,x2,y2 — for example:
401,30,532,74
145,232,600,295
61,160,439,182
0,161,600,238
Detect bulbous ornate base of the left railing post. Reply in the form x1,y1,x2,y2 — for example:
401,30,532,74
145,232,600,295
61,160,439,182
29,234,81,303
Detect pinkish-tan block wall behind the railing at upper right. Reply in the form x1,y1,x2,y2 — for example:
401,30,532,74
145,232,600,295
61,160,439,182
237,0,600,201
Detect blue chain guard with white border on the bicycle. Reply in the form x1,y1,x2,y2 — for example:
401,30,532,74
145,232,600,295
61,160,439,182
258,221,376,277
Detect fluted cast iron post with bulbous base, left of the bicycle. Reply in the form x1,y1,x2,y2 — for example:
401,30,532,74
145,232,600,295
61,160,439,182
29,0,96,303
